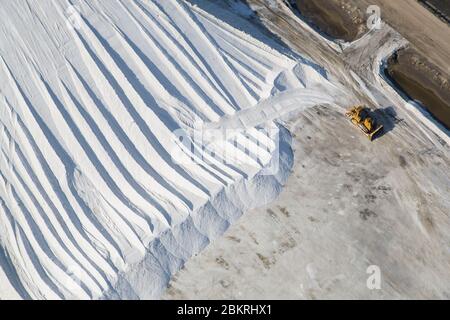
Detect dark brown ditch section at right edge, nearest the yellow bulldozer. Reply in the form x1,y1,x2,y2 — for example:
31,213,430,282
387,49,450,128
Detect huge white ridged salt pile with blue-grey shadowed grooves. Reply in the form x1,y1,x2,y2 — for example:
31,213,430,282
0,0,336,299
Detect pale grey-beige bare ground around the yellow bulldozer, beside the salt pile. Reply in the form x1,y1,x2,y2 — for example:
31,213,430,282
162,0,450,299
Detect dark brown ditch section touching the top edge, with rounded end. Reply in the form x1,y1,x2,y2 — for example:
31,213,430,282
296,0,366,42
